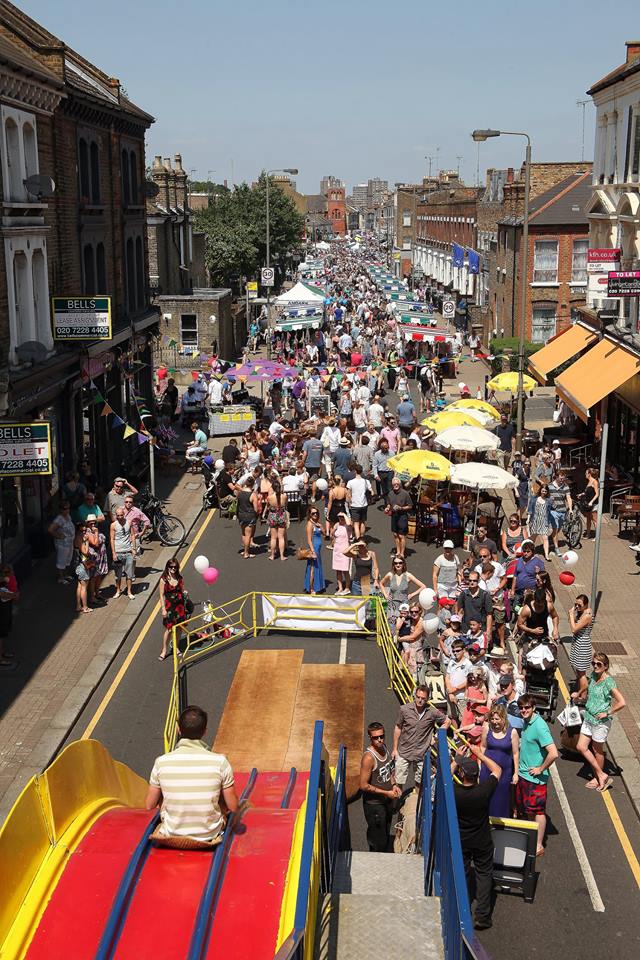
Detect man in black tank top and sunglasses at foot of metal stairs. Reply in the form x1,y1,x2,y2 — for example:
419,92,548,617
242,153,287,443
360,721,401,853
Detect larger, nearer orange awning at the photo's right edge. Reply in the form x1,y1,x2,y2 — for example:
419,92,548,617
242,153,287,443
556,340,640,423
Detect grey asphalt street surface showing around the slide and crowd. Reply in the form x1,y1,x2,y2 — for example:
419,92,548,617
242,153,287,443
62,452,640,960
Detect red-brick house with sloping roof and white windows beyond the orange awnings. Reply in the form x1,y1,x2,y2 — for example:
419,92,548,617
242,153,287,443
493,164,591,343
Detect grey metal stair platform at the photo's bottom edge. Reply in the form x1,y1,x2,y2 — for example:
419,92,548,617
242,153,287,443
315,892,444,960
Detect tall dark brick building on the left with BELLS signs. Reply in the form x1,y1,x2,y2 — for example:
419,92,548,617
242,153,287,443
0,0,157,567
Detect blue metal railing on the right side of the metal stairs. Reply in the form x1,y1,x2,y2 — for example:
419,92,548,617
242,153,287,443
419,730,489,960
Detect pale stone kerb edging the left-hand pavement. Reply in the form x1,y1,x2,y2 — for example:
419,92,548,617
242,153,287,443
0,507,203,825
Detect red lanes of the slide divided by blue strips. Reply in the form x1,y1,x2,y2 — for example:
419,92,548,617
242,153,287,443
26,773,308,960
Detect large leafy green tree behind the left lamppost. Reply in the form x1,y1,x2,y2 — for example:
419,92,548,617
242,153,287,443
195,174,303,286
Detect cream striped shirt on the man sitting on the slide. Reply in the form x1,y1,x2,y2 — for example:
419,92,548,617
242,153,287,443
149,739,233,840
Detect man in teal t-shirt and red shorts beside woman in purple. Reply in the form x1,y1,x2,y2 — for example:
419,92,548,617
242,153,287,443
516,693,558,857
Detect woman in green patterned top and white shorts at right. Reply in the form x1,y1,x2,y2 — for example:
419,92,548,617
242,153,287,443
571,651,626,793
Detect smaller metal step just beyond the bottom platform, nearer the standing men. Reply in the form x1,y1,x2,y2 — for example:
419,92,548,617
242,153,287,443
333,851,424,897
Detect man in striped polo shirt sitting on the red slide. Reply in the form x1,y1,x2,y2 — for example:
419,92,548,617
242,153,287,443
146,707,238,840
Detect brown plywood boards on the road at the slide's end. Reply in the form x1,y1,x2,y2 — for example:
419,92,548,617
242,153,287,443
213,650,364,790
